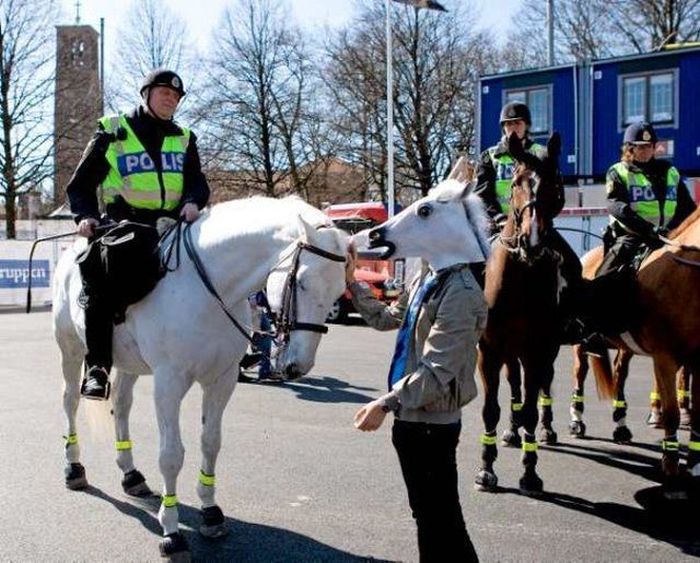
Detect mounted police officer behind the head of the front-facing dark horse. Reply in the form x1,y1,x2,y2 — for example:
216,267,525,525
474,102,585,342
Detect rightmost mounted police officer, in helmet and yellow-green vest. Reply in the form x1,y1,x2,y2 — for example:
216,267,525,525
596,122,695,277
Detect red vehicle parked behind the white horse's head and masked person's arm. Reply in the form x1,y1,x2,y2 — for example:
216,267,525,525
323,201,403,323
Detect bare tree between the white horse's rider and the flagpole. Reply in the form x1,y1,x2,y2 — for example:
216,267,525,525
205,0,319,197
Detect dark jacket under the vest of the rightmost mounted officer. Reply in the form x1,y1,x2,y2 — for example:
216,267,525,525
605,158,695,237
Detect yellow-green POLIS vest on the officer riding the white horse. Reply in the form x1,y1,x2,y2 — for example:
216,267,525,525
100,115,190,211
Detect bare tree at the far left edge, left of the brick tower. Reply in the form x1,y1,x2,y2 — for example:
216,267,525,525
0,0,58,239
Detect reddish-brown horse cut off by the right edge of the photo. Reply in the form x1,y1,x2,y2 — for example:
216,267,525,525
592,209,700,498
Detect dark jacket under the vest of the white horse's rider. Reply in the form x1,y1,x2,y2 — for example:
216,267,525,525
66,106,209,223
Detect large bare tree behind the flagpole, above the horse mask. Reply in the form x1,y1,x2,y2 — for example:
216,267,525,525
325,2,493,203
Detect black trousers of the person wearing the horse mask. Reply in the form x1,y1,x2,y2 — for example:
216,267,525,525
392,420,479,563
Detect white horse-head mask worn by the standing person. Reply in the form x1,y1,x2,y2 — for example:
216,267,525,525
364,179,490,270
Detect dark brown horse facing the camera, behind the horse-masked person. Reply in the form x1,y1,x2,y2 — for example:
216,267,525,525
475,136,563,494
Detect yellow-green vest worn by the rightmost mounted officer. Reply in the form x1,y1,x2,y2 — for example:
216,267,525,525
613,162,680,227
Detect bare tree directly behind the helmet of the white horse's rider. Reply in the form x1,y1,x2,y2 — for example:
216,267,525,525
105,0,194,112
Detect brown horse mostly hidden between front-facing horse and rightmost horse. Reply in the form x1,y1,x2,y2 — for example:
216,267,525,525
569,246,690,444
